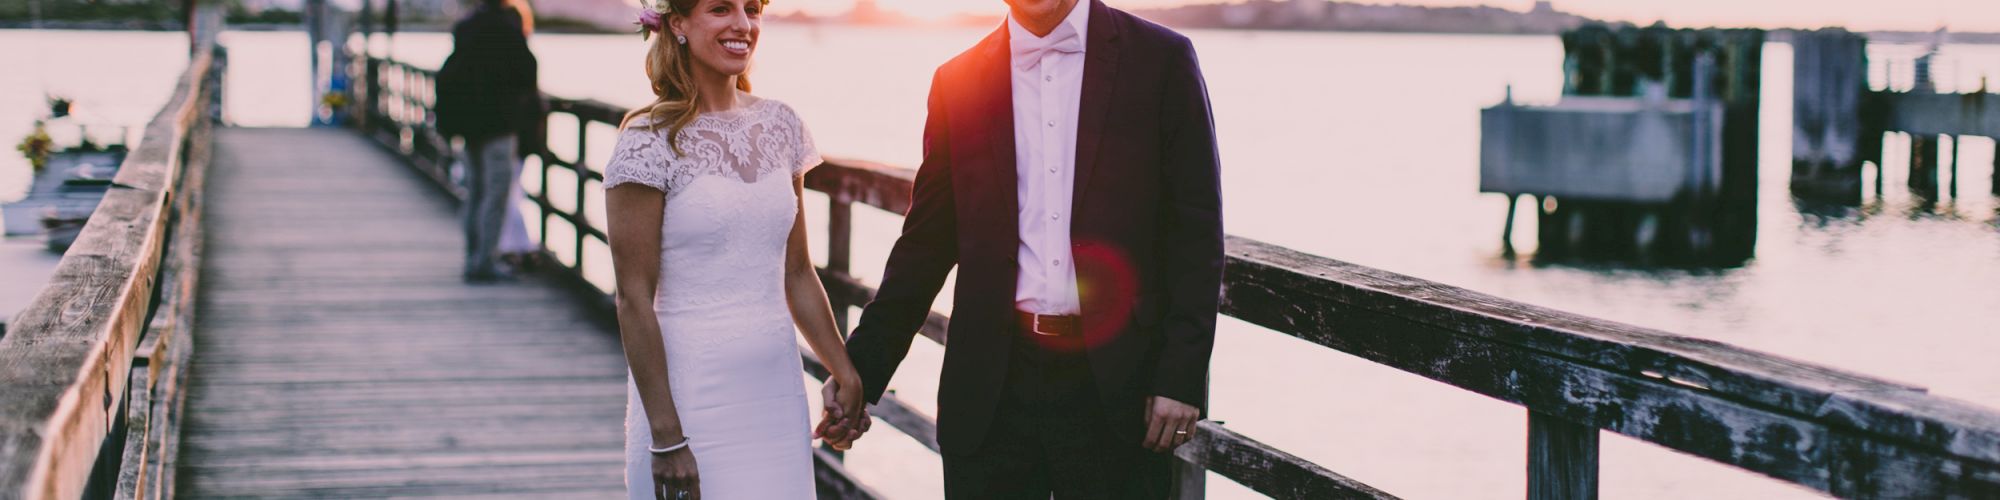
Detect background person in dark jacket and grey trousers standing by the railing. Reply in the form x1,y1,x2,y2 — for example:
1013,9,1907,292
436,0,542,282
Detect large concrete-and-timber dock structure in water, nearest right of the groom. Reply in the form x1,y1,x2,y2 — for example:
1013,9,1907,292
1480,26,1764,266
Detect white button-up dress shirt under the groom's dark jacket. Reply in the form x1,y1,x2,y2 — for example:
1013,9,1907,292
1006,2,1090,314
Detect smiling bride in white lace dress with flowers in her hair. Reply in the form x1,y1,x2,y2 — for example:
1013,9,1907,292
604,0,868,500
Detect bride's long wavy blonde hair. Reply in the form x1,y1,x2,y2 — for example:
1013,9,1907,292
624,0,770,154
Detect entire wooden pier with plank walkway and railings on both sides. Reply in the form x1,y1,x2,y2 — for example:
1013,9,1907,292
0,4,2000,500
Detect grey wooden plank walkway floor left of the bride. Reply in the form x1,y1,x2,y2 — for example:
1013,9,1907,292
180,128,626,498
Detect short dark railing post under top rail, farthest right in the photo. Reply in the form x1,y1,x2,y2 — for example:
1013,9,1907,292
1528,410,1598,500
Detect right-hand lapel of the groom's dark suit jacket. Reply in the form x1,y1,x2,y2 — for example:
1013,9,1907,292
1070,0,1118,216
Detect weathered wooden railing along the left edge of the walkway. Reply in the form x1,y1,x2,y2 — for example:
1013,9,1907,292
0,26,228,498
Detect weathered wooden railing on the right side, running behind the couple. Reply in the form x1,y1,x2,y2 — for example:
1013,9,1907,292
352,55,2000,498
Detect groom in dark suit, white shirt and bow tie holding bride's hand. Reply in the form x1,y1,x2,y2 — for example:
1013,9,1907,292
824,0,1222,498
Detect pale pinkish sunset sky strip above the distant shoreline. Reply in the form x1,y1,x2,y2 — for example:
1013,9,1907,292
772,0,2000,32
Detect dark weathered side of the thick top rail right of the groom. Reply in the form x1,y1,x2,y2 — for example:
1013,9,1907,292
1224,242,2000,496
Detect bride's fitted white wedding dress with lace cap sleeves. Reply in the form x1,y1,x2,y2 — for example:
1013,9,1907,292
604,94,820,500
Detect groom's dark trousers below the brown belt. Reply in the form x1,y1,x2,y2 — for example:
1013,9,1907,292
944,328,1172,500
